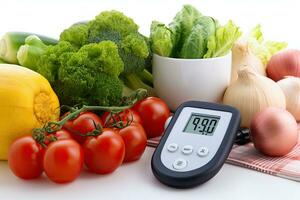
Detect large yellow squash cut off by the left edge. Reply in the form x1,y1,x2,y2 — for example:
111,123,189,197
0,64,59,160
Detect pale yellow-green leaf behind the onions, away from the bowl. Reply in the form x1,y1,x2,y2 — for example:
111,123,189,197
247,25,287,65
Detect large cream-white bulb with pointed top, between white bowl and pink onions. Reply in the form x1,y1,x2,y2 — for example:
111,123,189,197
223,66,285,128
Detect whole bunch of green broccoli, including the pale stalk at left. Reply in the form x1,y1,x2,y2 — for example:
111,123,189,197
18,11,153,106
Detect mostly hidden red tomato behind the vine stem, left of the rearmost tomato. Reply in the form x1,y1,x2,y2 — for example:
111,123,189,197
101,108,143,127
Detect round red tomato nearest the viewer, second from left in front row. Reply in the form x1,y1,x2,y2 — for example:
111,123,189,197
43,139,83,183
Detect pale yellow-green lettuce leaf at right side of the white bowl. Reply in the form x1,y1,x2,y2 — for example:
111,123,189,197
203,20,242,58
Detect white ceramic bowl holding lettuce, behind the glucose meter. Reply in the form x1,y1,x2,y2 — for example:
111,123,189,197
153,53,231,111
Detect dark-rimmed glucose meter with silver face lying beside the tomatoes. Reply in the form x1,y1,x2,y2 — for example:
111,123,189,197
151,101,240,188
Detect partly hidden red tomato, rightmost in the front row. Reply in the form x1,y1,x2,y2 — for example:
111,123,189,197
119,123,147,162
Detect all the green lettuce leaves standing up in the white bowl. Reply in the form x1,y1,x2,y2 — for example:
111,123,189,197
150,5,241,59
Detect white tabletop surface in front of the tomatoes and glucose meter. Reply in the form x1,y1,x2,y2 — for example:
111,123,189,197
0,147,300,200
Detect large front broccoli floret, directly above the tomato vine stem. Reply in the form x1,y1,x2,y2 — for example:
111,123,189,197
57,41,123,105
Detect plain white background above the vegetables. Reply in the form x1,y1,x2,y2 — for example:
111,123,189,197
0,0,300,48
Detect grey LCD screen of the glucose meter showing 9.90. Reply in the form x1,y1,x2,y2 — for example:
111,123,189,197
183,113,220,136
